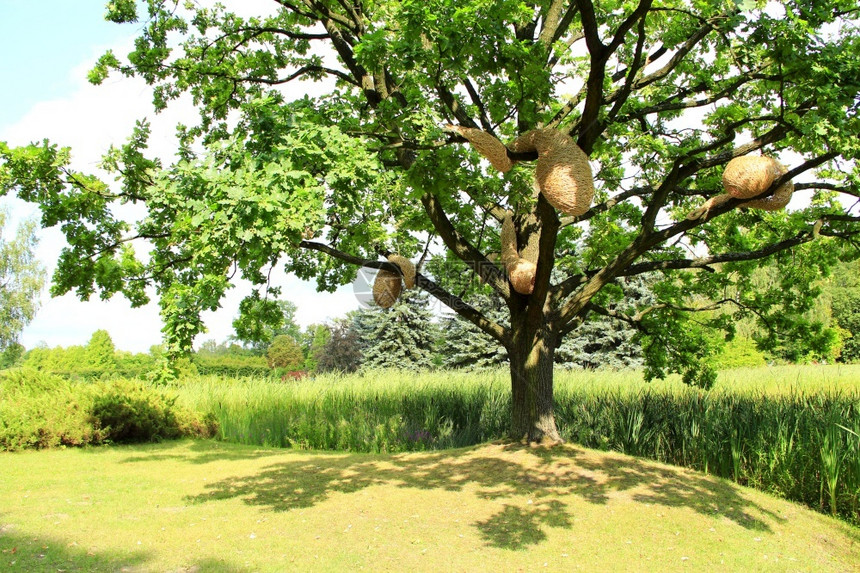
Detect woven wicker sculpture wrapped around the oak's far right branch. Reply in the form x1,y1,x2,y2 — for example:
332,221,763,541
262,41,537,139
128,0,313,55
687,155,794,220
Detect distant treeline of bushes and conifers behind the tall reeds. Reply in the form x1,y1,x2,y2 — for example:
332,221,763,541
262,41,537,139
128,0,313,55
5,256,860,379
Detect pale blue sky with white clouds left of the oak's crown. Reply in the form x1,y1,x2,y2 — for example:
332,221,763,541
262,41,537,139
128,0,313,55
0,0,359,352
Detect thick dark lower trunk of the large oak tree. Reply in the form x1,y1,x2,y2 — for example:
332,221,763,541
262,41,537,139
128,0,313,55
510,322,563,444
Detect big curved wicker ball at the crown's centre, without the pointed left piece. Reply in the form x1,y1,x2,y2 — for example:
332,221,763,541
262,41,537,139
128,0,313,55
511,129,594,216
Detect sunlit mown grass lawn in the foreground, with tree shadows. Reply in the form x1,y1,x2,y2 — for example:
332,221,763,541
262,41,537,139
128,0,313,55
0,440,860,571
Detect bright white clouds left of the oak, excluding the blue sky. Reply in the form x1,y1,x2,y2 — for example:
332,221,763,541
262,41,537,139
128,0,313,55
0,36,358,352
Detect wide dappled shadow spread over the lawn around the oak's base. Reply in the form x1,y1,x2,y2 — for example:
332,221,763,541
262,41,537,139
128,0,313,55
189,445,781,550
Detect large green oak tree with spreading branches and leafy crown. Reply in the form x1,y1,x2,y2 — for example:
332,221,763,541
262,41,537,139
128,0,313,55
0,0,860,440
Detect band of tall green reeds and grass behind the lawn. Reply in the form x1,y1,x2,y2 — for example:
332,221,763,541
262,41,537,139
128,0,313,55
0,366,860,524
